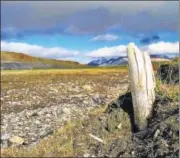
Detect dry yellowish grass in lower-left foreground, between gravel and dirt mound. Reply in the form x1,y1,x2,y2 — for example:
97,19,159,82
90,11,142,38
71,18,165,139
1,107,106,157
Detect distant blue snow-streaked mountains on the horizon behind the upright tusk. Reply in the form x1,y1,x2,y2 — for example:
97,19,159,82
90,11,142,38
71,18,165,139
88,54,177,66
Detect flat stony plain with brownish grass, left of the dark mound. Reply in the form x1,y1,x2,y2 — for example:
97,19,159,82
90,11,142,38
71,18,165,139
1,71,128,148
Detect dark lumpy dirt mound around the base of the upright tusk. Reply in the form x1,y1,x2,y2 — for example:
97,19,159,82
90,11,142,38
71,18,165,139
84,93,179,157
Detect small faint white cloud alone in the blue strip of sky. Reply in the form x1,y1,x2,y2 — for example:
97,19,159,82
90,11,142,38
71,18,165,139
91,34,119,41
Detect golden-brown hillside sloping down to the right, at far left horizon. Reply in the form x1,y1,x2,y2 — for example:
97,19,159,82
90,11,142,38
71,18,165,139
1,52,87,69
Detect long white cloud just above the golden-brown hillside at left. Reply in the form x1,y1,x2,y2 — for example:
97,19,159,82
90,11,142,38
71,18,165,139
1,41,79,59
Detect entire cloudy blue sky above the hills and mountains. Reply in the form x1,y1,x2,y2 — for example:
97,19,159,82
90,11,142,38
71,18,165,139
1,1,179,63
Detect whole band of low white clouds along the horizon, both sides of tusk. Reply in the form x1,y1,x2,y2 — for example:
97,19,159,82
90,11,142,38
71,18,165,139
1,41,179,63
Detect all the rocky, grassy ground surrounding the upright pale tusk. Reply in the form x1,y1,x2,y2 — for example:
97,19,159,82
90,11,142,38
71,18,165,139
1,70,179,158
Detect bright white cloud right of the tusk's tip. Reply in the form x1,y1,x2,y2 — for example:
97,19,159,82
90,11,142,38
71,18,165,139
143,42,179,54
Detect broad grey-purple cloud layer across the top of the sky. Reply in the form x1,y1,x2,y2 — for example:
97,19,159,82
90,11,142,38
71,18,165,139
1,1,179,37
